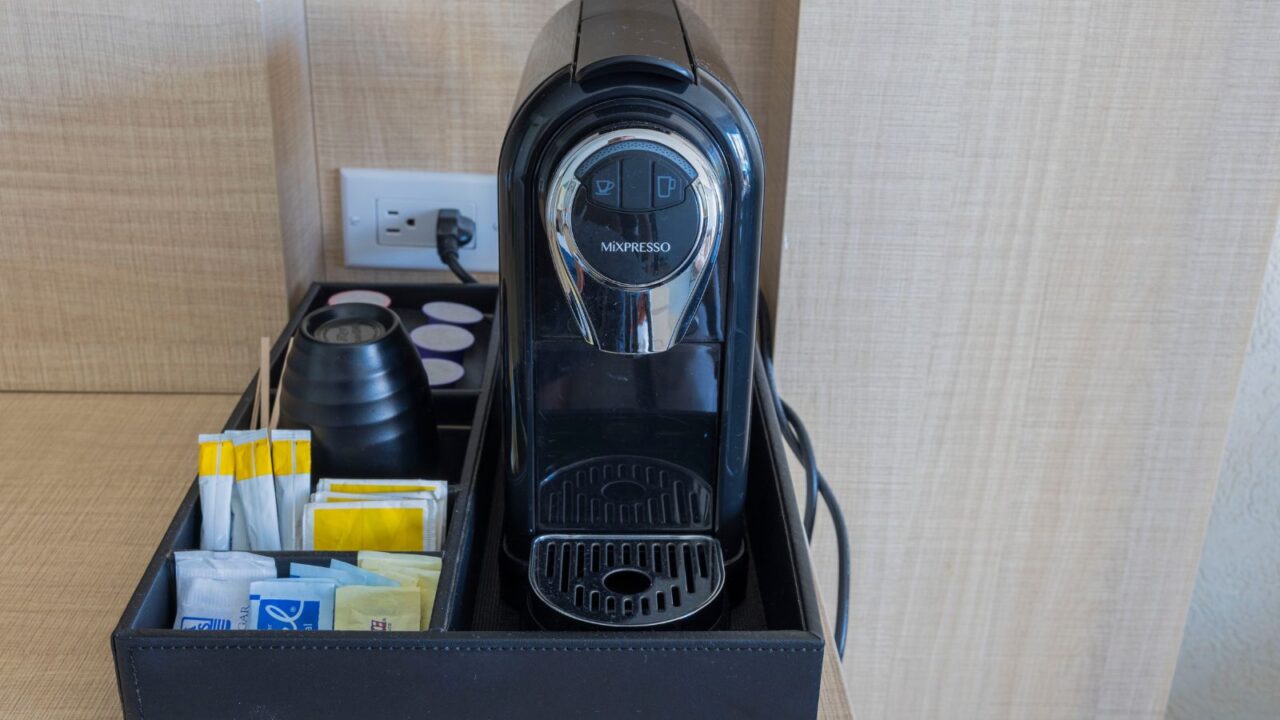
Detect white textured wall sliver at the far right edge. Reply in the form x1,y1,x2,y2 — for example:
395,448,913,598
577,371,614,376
1169,230,1280,720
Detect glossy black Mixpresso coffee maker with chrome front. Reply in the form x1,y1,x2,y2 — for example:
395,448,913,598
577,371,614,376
499,0,764,629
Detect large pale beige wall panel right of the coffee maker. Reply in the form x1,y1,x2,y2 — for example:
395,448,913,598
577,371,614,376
778,0,1280,719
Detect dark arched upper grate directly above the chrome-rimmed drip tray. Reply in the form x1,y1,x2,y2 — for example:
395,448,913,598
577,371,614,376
538,455,712,532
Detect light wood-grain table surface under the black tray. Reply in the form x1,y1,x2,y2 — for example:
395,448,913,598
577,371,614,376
0,393,852,720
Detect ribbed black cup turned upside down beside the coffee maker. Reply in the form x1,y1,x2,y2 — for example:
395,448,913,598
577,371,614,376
279,304,439,479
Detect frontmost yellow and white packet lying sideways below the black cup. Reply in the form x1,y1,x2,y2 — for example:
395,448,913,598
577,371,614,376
302,498,440,552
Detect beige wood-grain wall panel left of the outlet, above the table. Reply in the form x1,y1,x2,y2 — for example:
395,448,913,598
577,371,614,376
0,0,285,391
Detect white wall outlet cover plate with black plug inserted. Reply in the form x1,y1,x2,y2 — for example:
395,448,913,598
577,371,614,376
339,168,498,273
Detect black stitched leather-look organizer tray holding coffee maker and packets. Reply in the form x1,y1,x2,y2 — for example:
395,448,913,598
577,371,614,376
111,283,823,720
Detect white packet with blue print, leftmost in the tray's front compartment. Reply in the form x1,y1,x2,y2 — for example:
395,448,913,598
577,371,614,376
173,550,275,630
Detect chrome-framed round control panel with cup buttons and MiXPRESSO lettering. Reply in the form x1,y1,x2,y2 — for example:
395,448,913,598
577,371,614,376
544,128,724,354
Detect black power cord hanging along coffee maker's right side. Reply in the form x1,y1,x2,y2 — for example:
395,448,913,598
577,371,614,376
756,293,852,660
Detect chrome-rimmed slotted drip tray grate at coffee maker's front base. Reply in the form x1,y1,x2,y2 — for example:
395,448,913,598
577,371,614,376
529,536,724,628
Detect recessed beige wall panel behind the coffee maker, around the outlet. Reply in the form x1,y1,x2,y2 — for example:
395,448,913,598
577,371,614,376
307,0,790,282
